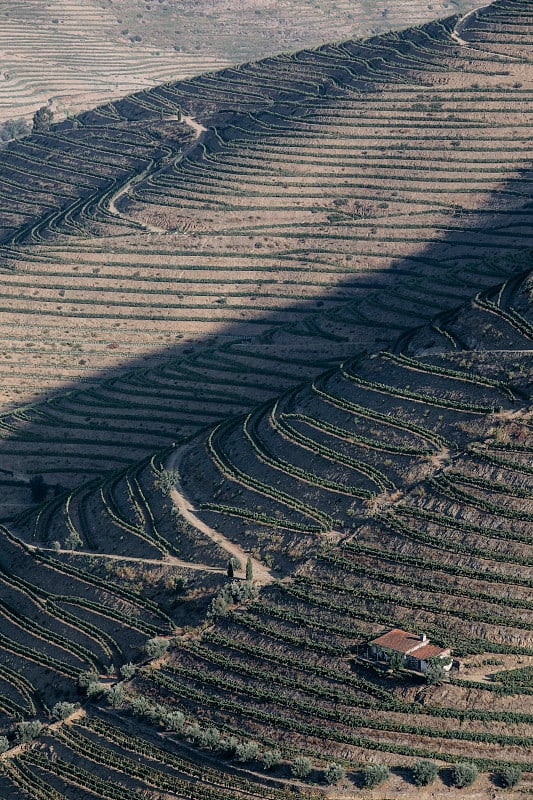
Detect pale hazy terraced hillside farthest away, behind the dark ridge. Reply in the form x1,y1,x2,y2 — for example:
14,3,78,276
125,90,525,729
0,0,480,125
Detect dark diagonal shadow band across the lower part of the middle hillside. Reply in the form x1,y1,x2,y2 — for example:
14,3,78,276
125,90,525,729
0,156,533,516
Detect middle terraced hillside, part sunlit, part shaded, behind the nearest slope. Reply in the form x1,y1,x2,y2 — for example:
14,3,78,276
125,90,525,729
0,2,531,508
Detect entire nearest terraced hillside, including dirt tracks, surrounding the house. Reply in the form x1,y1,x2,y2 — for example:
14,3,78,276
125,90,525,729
0,271,533,800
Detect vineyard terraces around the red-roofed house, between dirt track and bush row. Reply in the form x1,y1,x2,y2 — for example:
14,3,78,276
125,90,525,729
120,273,533,796
